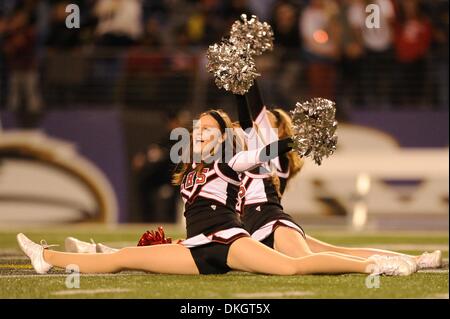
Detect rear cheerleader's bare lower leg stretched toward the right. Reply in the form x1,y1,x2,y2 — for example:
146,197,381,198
306,235,418,258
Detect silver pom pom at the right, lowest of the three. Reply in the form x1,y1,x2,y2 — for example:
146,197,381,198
291,98,338,165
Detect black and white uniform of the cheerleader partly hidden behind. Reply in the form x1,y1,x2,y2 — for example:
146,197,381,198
236,86,305,248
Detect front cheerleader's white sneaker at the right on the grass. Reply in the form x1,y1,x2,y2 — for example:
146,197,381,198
368,255,413,276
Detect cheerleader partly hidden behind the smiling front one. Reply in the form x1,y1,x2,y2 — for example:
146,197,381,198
237,83,442,269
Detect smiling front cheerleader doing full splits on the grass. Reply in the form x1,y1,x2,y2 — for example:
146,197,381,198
17,111,412,275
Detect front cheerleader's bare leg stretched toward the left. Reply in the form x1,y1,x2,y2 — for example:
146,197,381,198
44,244,199,275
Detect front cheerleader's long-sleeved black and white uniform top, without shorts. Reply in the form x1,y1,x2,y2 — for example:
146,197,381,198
180,139,291,246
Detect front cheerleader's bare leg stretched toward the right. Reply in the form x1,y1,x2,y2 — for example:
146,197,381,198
227,237,373,275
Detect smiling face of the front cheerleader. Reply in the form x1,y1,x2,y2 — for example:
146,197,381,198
192,114,222,159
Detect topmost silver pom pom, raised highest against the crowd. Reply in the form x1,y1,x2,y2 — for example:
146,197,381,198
230,14,273,56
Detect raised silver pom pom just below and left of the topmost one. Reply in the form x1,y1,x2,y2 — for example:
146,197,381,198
206,40,260,95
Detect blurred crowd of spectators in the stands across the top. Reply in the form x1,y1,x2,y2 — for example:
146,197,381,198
0,0,448,115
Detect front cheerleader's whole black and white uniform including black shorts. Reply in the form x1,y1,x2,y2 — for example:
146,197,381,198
180,141,285,274
